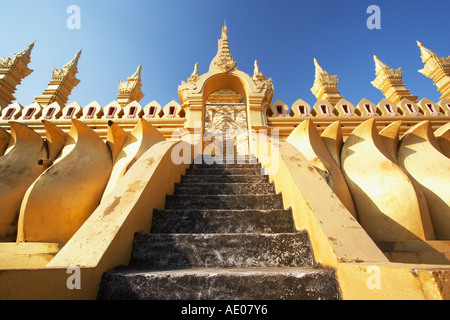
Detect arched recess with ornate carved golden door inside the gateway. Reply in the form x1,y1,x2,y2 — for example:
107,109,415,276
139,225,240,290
204,89,249,155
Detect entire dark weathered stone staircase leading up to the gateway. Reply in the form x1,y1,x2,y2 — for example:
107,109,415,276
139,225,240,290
98,157,340,300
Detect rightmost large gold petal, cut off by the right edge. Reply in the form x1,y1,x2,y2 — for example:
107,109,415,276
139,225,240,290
398,121,450,240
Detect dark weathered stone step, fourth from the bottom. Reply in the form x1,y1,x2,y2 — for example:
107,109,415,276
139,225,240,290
166,194,284,210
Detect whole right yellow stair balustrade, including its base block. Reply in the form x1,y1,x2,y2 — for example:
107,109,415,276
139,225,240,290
256,136,450,300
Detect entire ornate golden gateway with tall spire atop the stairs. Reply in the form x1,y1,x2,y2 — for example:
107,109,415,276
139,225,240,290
178,25,274,160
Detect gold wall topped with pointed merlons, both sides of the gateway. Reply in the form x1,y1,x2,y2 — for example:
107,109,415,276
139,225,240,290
0,99,450,140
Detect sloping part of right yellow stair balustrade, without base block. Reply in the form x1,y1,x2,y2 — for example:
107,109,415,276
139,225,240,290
256,139,388,268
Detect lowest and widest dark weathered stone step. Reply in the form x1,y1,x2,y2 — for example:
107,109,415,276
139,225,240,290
98,268,340,300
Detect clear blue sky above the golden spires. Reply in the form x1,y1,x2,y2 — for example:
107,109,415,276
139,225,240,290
0,0,450,107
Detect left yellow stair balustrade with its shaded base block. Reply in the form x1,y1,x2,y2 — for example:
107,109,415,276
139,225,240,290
0,141,193,300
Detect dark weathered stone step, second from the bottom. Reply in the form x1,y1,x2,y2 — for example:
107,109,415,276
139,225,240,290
130,233,314,269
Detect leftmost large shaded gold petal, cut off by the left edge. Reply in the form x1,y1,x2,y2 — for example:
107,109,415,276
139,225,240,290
0,122,48,242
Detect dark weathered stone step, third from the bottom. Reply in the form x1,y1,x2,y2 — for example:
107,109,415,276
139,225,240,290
151,210,295,233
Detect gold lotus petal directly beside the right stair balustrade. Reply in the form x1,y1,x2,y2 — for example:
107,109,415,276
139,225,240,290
286,119,357,218
